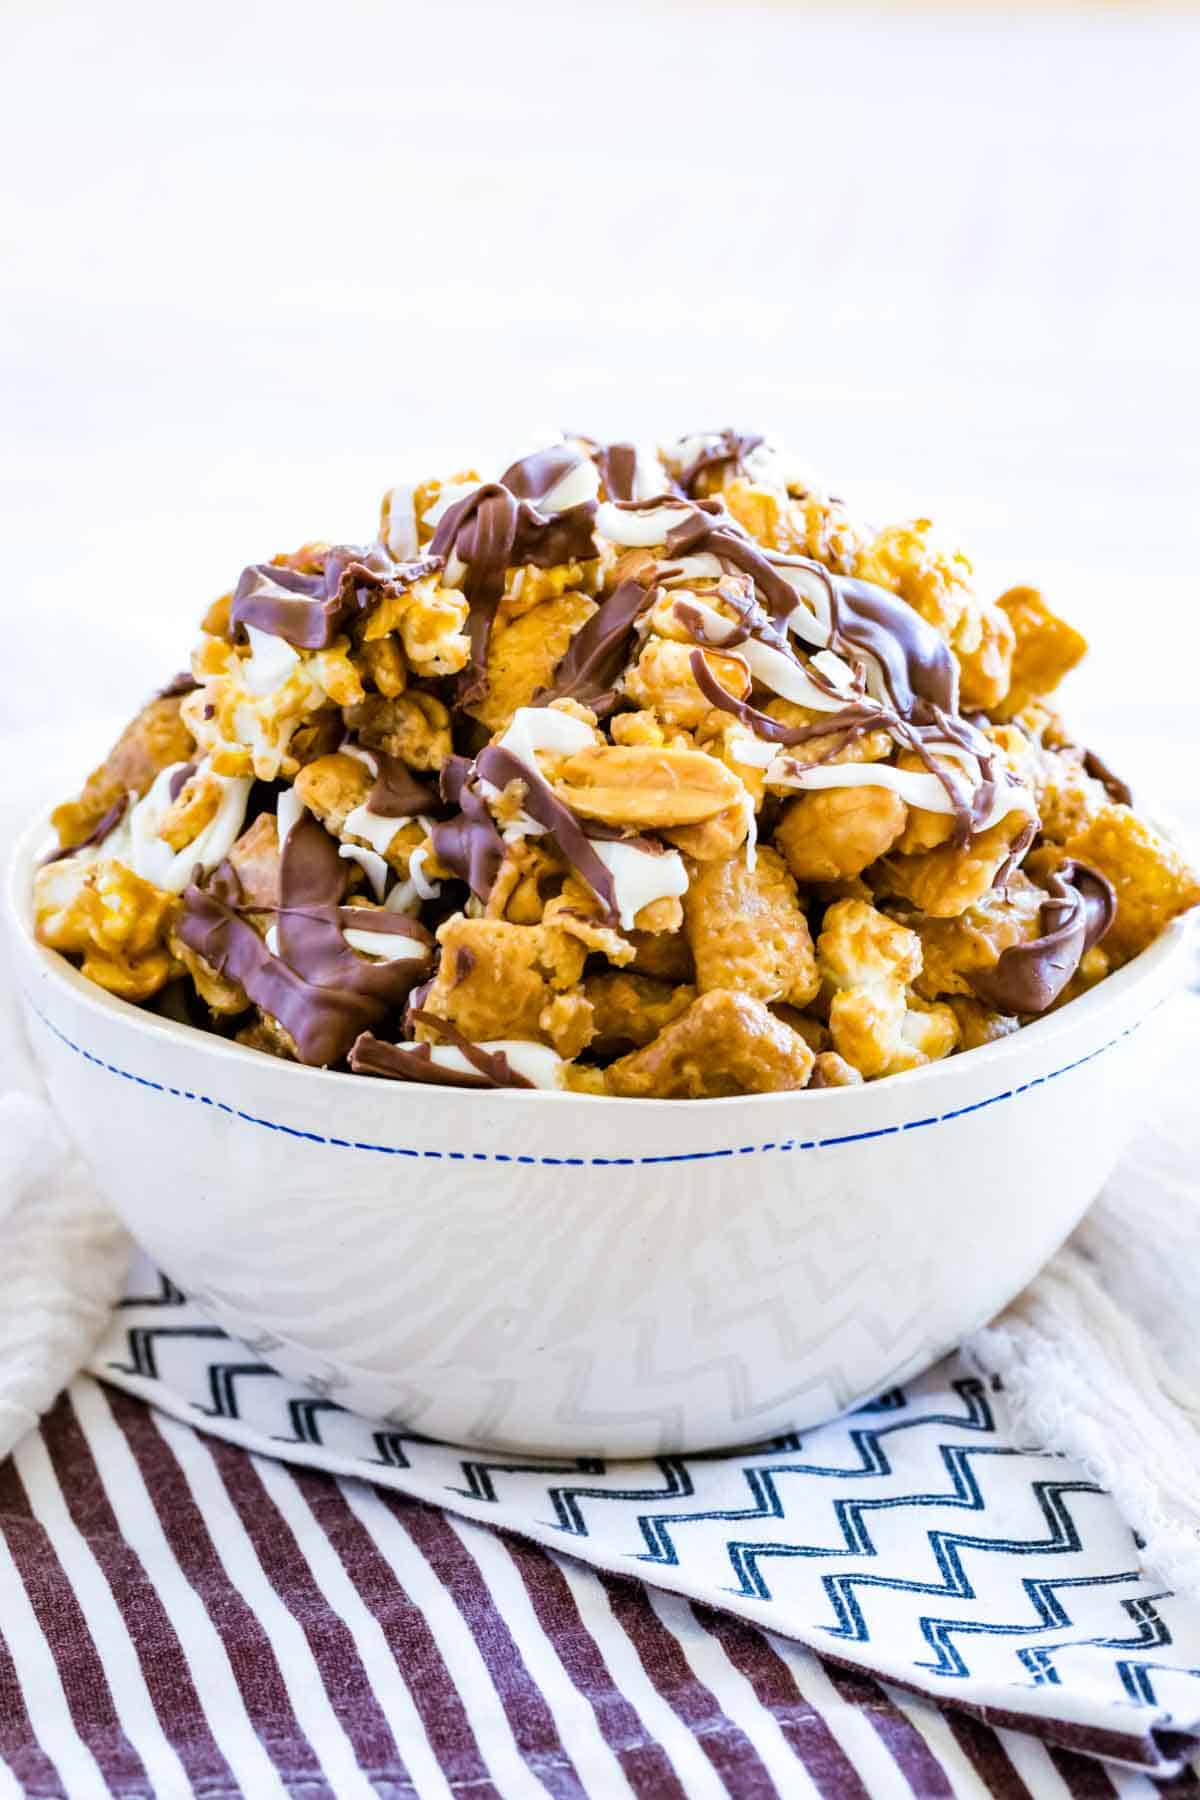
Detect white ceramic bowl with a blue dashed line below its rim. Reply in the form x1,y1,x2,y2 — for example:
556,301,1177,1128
9,823,1186,1456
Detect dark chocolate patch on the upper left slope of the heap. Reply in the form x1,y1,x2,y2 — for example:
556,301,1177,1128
228,544,443,650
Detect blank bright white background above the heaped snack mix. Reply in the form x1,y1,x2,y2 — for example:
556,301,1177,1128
0,0,1200,815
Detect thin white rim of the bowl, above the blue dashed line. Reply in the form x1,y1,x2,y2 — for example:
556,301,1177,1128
4,810,1193,1118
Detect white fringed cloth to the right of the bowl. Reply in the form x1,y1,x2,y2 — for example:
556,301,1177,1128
964,995,1200,1598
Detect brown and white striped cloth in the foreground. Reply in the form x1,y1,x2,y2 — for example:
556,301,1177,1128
0,1353,1200,1800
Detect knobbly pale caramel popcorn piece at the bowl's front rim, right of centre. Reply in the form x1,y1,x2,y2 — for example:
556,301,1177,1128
817,900,959,1080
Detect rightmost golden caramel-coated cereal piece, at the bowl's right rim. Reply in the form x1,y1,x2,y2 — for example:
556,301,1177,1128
1063,805,1200,958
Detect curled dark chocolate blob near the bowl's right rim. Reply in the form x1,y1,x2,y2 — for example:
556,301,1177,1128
970,860,1117,1013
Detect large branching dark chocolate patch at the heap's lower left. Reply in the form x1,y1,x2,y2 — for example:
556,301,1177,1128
178,814,428,1067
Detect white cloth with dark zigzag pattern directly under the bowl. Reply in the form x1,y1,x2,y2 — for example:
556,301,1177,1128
77,1264,1200,1786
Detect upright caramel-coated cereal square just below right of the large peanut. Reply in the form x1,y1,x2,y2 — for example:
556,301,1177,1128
684,848,820,1006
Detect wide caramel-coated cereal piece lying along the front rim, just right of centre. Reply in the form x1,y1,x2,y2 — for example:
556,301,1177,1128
606,988,813,1100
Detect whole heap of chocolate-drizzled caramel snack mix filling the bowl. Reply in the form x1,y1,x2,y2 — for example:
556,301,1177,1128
34,432,1200,1100
